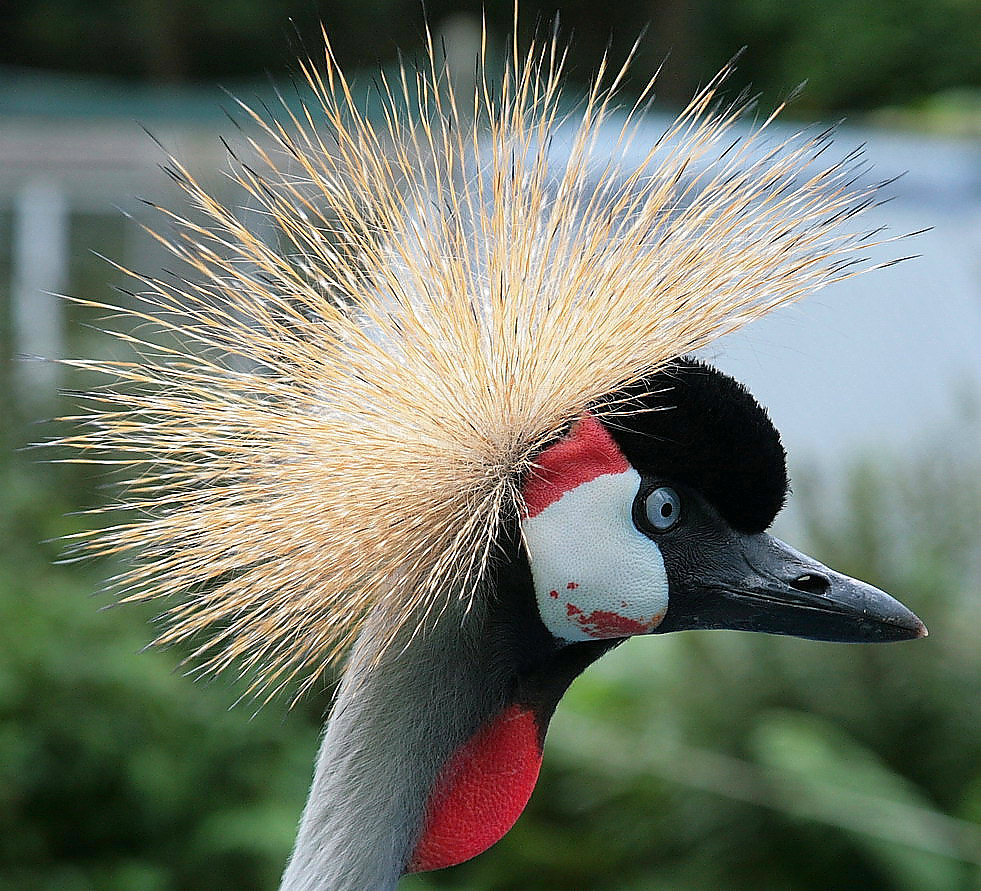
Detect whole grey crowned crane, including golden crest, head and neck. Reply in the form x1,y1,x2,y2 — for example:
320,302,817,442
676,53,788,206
63,19,926,891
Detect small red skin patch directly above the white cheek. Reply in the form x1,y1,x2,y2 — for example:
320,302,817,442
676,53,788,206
522,413,630,518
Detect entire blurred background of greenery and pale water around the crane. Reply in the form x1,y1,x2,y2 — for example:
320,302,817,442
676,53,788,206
0,0,981,891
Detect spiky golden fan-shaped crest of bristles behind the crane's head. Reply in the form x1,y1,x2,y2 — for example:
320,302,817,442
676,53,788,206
53,22,888,695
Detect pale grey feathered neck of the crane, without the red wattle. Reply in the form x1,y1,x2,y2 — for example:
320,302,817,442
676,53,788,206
280,604,507,891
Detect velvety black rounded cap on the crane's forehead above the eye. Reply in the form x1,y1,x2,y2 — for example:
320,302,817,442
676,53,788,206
607,357,788,533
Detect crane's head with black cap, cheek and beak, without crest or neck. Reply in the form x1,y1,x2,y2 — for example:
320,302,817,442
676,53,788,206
521,360,926,642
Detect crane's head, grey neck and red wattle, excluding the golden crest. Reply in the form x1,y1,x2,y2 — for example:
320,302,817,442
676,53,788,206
283,360,926,889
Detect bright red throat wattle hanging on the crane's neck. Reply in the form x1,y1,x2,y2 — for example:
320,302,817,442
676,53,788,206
406,706,542,872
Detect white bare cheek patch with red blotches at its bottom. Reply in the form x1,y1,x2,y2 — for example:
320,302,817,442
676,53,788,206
521,470,668,641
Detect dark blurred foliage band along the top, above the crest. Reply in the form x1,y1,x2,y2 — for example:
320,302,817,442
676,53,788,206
0,0,981,112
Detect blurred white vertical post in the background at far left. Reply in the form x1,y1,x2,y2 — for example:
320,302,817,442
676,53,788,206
11,179,69,413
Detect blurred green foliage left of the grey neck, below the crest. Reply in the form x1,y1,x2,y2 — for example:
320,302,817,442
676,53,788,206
0,456,330,891
